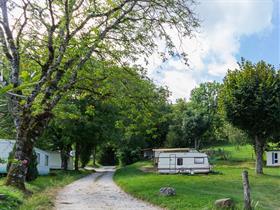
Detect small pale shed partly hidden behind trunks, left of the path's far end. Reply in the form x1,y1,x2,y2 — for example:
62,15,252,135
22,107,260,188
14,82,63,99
48,151,74,170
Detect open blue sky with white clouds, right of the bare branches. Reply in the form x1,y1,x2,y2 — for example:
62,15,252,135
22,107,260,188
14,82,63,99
147,0,280,101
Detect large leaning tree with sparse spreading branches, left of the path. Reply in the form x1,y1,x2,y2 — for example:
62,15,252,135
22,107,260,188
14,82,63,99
0,0,198,190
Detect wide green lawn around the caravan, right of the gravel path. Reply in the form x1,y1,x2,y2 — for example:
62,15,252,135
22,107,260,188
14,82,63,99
114,146,280,210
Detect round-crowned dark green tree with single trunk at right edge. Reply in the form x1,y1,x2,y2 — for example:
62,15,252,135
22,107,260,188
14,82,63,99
219,60,280,174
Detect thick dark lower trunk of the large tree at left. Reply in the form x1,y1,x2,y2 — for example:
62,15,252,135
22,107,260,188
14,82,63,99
6,129,34,191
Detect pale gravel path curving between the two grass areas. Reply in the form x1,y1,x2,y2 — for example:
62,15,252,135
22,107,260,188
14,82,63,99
55,167,160,210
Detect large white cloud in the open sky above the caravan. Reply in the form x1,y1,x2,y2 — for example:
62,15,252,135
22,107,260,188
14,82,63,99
145,0,273,101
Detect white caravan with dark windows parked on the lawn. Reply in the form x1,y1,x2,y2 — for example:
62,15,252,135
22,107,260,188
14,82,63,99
154,148,211,174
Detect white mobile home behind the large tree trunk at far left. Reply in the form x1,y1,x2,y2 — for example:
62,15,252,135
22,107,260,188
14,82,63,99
0,140,50,175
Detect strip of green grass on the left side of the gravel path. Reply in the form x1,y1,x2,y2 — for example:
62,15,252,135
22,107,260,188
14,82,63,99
0,171,90,210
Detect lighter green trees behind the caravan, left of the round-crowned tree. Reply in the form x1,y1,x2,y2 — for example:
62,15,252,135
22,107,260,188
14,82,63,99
166,82,222,149
